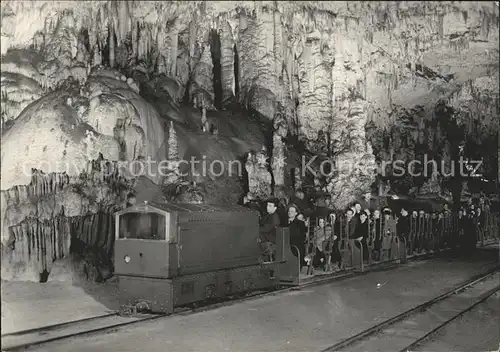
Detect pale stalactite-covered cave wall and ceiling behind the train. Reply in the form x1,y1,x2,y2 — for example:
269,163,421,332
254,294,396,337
0,0,499,277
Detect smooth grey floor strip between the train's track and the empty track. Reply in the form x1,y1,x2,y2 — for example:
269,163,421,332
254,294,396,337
9,248,498,352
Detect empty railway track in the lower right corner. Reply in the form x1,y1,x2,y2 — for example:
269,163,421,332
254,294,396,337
321,266,500,352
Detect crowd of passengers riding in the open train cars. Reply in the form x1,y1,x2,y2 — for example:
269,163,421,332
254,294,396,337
244,190,492,270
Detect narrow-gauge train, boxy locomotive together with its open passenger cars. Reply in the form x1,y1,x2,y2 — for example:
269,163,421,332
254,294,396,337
114,203,498,314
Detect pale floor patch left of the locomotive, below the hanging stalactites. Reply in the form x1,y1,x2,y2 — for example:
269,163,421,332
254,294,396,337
1,280,119,335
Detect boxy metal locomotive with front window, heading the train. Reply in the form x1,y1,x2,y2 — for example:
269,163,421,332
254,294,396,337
114,202,292,314
